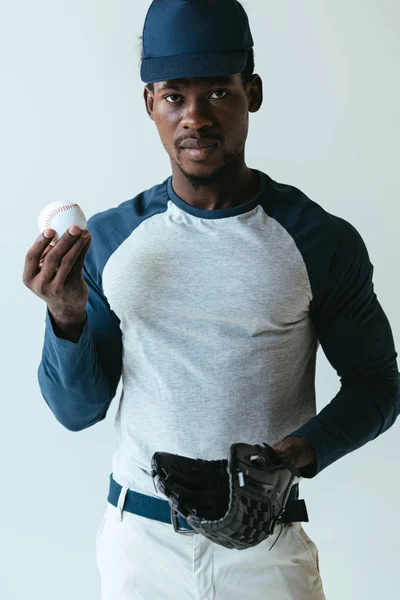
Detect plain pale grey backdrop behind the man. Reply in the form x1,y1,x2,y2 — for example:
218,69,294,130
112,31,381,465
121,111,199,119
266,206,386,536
0,0,400,600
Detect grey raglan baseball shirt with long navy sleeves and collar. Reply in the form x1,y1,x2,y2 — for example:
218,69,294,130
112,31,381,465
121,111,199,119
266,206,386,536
38,171,400,497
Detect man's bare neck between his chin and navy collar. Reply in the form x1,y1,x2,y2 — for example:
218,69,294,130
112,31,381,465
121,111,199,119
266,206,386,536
172,157,260,210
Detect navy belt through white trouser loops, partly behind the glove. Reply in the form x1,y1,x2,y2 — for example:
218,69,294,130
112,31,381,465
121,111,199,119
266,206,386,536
107,473,299,534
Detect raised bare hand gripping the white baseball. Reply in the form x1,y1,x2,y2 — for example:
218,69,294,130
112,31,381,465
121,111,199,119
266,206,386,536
23,227,91,322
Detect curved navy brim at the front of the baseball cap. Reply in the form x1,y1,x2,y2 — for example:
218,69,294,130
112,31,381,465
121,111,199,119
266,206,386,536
140,50,247,83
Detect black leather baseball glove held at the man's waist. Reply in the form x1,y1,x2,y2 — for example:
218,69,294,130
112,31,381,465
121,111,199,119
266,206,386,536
151,444,308,550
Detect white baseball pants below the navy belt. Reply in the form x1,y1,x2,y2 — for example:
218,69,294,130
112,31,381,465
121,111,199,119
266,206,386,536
96,503,325,600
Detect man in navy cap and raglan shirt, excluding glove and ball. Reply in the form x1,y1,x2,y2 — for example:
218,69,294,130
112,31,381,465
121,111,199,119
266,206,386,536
24,0,400,600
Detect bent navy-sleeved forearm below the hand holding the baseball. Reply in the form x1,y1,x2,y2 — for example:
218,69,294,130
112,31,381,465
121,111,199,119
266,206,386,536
38,313,118,431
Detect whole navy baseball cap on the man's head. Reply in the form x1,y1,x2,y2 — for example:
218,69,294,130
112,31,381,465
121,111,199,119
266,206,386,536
140,0,254,83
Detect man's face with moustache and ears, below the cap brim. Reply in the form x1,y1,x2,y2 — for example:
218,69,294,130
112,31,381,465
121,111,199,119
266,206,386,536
144,73,262,181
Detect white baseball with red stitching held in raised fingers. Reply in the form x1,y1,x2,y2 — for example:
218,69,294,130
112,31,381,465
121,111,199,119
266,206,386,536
38,202,87,240
